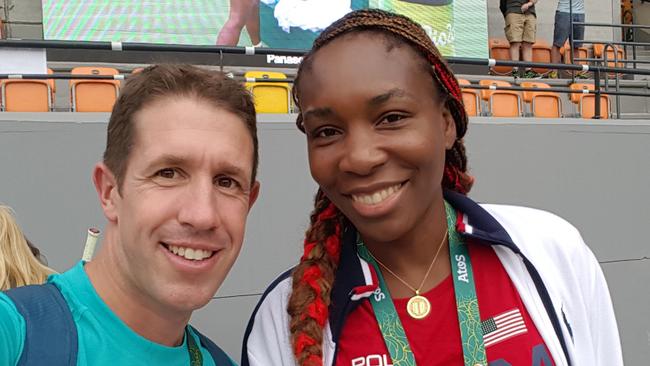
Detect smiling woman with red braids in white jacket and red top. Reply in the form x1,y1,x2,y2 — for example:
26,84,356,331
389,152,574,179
242,10,622,366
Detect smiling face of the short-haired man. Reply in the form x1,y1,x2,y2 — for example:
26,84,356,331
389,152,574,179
109,97,259,312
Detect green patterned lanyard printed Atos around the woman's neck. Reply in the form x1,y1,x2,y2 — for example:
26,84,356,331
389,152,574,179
357,202,487,366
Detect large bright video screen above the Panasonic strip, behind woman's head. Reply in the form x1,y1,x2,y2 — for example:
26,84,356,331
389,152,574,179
42,0,488,58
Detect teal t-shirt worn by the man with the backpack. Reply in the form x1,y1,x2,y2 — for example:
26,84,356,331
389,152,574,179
0,262,235,366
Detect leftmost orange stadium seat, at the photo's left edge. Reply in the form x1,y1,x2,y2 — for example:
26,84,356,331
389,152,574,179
1,79,52,112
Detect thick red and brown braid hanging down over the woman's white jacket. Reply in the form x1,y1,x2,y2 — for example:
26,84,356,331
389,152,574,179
287,190,342,366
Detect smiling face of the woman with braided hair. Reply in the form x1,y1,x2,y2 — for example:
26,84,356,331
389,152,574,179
299,32,456,242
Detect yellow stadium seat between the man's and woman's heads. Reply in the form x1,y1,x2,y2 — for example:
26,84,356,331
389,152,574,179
244,71,291,113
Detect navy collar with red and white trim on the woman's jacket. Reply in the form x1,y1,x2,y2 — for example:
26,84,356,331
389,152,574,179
329,190,520,343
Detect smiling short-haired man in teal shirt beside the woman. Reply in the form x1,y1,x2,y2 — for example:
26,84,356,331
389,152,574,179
0,65,259,366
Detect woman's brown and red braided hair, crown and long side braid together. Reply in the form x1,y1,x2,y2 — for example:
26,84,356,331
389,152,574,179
288,9,474,366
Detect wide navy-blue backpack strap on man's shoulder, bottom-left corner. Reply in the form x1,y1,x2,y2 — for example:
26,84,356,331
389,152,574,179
5,283,78,366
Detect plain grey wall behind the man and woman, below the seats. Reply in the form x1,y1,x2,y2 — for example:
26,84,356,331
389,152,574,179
0,113,650,365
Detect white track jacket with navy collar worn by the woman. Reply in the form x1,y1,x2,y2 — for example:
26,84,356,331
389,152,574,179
241,191,623,366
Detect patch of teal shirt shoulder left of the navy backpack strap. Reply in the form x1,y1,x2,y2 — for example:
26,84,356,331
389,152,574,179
0,292,25,366
